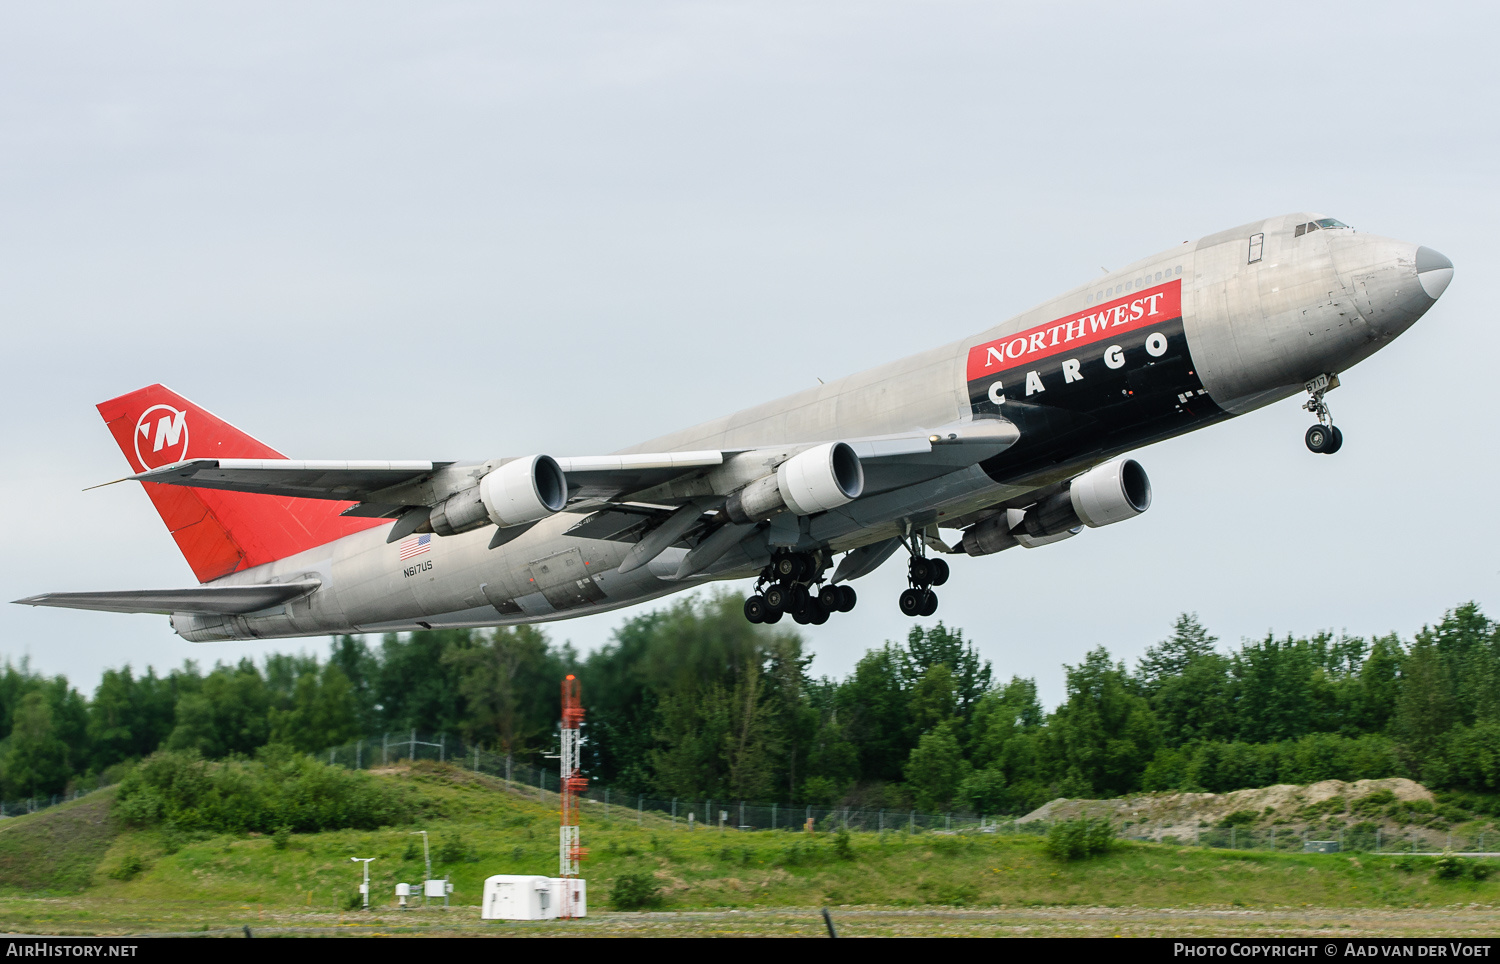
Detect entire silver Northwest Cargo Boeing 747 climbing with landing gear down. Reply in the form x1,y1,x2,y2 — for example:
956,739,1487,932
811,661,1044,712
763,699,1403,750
20,214,1454,642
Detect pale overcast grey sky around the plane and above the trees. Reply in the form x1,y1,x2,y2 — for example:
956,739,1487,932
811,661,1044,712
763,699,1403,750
0,0,1500,702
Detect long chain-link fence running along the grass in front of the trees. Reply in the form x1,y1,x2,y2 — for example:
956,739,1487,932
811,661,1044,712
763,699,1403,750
320,730,1500,853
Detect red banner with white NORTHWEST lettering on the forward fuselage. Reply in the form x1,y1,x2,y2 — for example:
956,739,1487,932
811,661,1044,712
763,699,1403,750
969,279,1182,381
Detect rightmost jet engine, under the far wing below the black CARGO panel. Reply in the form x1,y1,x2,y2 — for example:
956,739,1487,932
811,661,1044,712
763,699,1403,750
960,459,1151,556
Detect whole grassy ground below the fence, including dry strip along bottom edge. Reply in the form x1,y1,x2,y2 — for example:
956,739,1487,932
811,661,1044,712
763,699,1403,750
0,765,1500,936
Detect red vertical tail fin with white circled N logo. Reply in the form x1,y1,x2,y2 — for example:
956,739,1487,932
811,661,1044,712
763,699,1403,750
98,385,383,582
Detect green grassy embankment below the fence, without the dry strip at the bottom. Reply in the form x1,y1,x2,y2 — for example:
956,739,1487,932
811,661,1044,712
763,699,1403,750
0,765,1500,933
